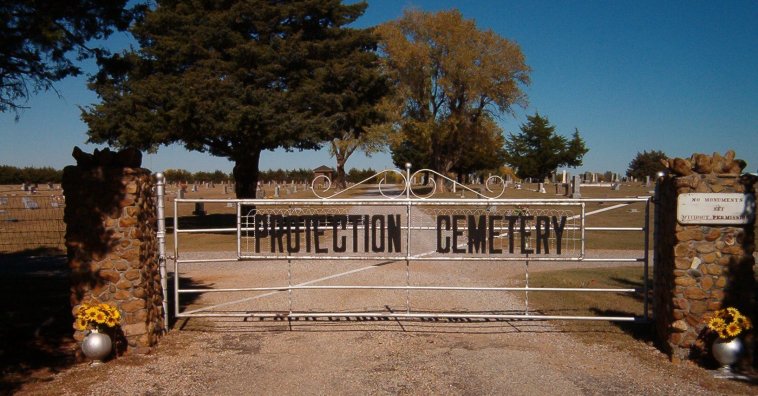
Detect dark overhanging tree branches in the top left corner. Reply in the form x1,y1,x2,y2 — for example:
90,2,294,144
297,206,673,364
0,0,145,117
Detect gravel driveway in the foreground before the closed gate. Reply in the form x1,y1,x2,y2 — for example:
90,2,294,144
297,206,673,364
18,254,758,395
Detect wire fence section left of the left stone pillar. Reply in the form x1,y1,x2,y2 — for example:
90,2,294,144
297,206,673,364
0,185,66,253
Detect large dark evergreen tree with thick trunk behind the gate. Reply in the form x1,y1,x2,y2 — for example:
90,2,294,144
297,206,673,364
82,0,386,198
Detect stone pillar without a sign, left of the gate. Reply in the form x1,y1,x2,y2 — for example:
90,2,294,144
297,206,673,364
63,147,166,353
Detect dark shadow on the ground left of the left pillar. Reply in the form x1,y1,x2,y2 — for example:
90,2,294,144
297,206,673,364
0,250,76,394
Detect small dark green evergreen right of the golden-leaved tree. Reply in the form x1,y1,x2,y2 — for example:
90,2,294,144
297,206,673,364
505,113,589,180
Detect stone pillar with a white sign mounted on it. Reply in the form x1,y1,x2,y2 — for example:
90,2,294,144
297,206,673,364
653,151,758,364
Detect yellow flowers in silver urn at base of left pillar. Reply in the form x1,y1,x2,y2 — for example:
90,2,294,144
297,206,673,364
74,303,121,365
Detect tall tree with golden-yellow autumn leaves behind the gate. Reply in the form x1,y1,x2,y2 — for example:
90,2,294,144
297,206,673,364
377,10,530,179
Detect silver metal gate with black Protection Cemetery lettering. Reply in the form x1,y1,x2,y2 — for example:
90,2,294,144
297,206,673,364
159,170,651,321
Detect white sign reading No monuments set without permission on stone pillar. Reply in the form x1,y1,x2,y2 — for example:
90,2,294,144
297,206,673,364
676,193,755,224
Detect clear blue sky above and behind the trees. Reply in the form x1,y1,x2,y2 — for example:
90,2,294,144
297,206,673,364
0,0,758,173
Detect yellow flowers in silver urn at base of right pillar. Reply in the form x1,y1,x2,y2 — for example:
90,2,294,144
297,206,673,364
708,307,753,375
